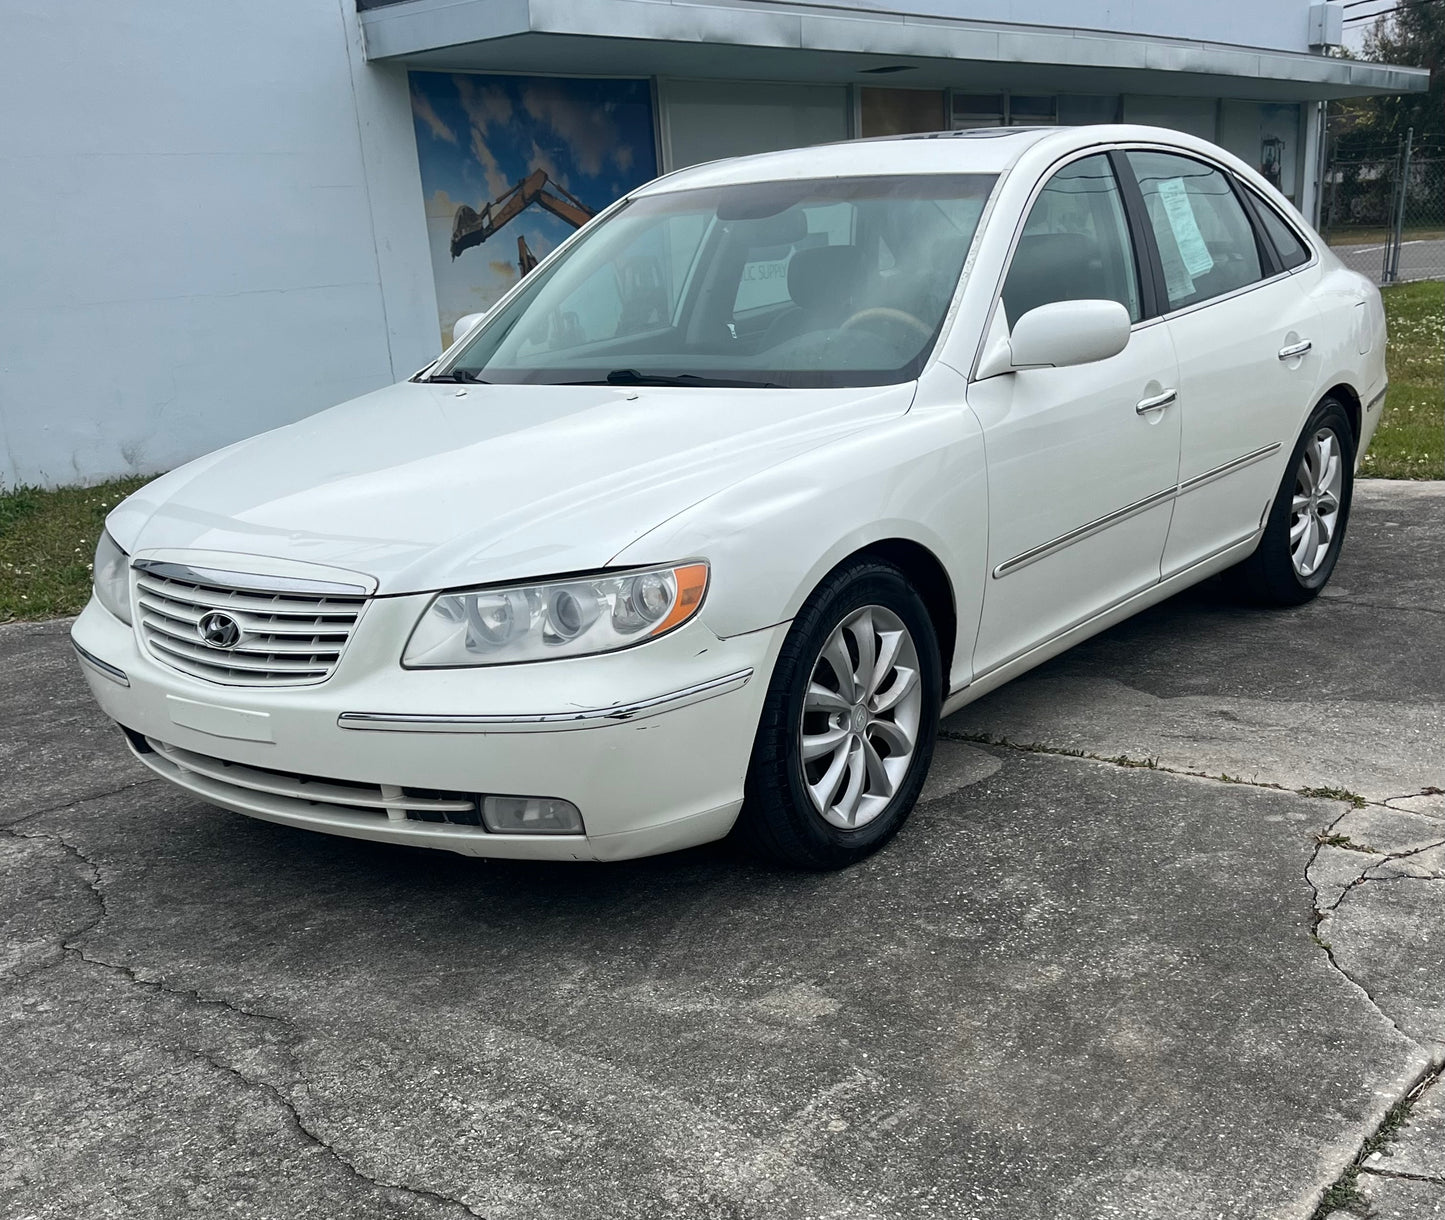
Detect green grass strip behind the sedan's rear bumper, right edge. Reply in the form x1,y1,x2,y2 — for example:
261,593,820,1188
1360,280,1445,478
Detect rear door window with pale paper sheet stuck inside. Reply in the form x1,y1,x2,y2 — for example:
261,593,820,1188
1129,152,1263,309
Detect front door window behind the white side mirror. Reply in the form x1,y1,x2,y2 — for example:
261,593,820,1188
1003,156,1142,327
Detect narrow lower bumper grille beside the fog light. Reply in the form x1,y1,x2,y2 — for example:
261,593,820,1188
126,730,486,834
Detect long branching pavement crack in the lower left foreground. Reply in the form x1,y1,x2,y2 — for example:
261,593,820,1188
0,815,486,1220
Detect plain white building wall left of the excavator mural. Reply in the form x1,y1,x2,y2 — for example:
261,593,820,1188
0,0,439,486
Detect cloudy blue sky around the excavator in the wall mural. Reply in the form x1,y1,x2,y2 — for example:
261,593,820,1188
410,72,657,340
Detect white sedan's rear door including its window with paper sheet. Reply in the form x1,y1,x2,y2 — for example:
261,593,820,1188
1124,149,1319,578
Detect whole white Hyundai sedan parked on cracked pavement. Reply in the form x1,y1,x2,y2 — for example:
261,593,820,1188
74,127,1386,869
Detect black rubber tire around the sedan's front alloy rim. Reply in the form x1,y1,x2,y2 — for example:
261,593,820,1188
744,561,942,869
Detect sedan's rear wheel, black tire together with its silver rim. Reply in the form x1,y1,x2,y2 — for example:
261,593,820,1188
1230,398,1355,606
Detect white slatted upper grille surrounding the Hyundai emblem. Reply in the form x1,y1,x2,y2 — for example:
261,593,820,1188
136,567,366,687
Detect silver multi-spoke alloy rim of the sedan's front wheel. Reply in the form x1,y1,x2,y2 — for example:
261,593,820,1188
799,606,923,830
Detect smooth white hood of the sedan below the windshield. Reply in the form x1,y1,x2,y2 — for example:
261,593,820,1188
107,382,913,593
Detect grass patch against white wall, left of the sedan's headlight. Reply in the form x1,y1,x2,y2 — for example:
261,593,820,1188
0,478,147,623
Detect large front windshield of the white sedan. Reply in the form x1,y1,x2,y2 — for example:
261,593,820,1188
434,173,994,387
